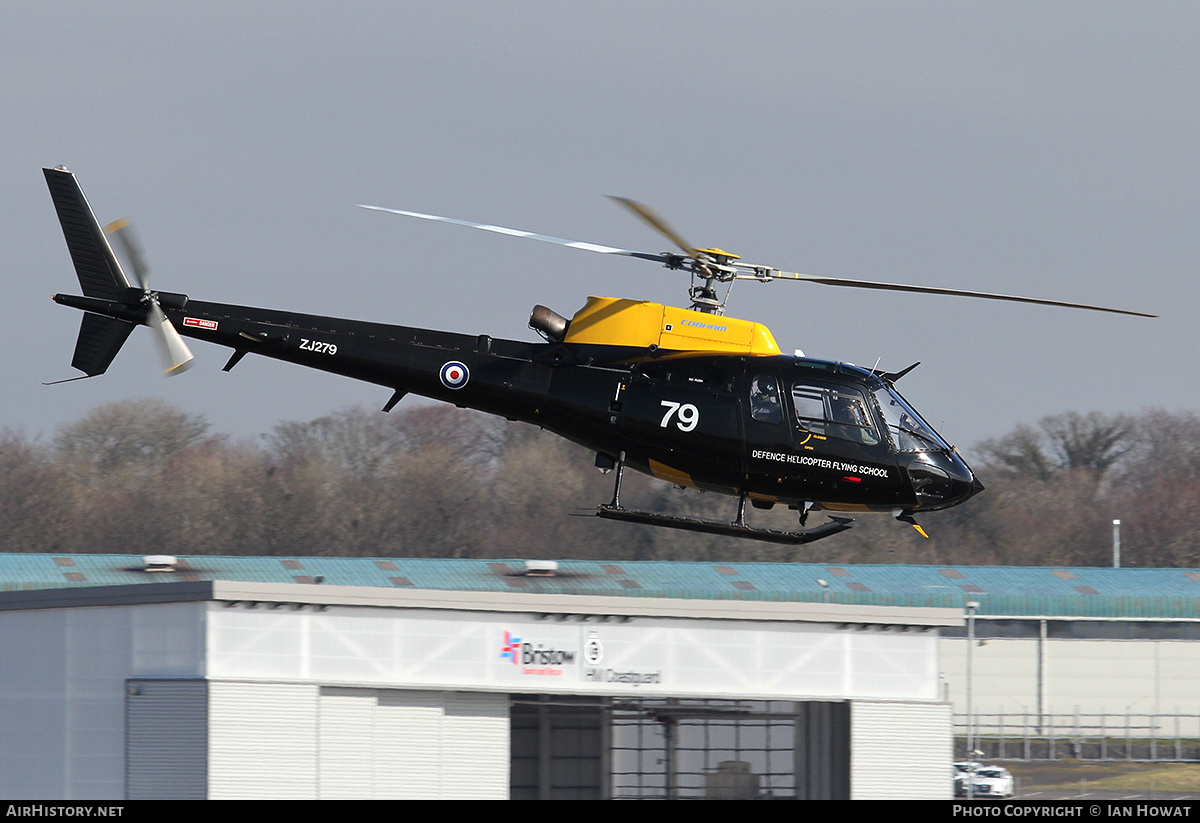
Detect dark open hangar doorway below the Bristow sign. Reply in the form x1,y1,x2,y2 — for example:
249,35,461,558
510,695,850,799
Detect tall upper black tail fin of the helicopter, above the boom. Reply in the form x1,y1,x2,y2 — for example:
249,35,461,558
42,167,130,299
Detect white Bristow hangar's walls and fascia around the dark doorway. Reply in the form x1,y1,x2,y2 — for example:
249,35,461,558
0,582,958,799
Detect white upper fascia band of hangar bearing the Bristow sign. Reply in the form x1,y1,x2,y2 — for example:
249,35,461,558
206,603,940,701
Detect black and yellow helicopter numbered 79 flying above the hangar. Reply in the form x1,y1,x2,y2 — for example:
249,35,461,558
43,167,1154,545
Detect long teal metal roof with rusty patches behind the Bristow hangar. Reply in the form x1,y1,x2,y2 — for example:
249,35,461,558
0,554,1200,619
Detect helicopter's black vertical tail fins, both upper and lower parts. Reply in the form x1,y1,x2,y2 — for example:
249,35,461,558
42,167,133,377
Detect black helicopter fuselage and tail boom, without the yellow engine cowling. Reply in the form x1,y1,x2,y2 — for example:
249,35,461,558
55,289,979,513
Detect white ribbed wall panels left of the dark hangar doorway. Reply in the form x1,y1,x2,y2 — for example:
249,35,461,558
208,681,509,800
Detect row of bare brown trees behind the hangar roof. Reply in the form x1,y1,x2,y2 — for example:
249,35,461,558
9,401,1200,565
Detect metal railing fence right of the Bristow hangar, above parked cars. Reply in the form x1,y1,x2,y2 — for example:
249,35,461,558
954,711,1200,761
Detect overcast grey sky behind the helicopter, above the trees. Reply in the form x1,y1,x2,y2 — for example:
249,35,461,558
0,0,1200,457
